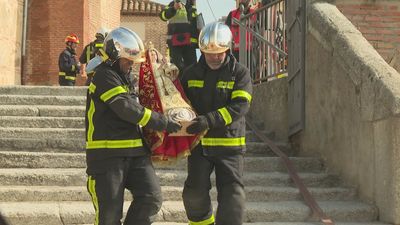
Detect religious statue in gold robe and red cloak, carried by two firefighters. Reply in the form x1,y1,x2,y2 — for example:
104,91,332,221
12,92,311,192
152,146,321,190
139,48,200,161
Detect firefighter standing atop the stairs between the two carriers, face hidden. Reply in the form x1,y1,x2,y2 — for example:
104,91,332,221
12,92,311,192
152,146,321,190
160,0,199,77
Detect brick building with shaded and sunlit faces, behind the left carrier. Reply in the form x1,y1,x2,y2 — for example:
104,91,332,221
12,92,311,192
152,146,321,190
23,0,121,85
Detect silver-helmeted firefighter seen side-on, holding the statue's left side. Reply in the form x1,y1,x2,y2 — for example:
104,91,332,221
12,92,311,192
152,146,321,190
86,27,181,225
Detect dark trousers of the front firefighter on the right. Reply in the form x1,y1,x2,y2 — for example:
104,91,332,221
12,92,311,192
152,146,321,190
182,145,245,225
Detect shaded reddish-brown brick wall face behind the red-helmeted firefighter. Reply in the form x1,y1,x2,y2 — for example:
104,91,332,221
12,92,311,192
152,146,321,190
23,0,85,85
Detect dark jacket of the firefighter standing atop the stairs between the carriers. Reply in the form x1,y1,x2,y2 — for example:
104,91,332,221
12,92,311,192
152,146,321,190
160,1,199,47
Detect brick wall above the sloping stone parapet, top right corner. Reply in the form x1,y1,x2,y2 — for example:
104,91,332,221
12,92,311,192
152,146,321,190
336,0,400,61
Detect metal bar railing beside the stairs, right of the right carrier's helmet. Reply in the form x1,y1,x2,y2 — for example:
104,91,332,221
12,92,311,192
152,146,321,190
233,0,288,83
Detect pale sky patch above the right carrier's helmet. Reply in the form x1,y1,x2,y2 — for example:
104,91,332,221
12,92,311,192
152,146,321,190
151,0,236,23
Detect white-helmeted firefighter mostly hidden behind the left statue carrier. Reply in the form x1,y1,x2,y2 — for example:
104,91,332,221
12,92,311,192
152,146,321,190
79,27,108,86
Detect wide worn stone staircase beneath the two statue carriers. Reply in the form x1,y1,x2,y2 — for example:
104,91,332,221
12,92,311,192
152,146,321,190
0,86,390,225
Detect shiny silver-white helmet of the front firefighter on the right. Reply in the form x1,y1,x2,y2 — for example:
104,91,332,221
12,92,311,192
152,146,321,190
199,22,232,53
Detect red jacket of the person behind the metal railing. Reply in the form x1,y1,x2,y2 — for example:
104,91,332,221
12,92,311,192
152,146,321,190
225,8,257,51
